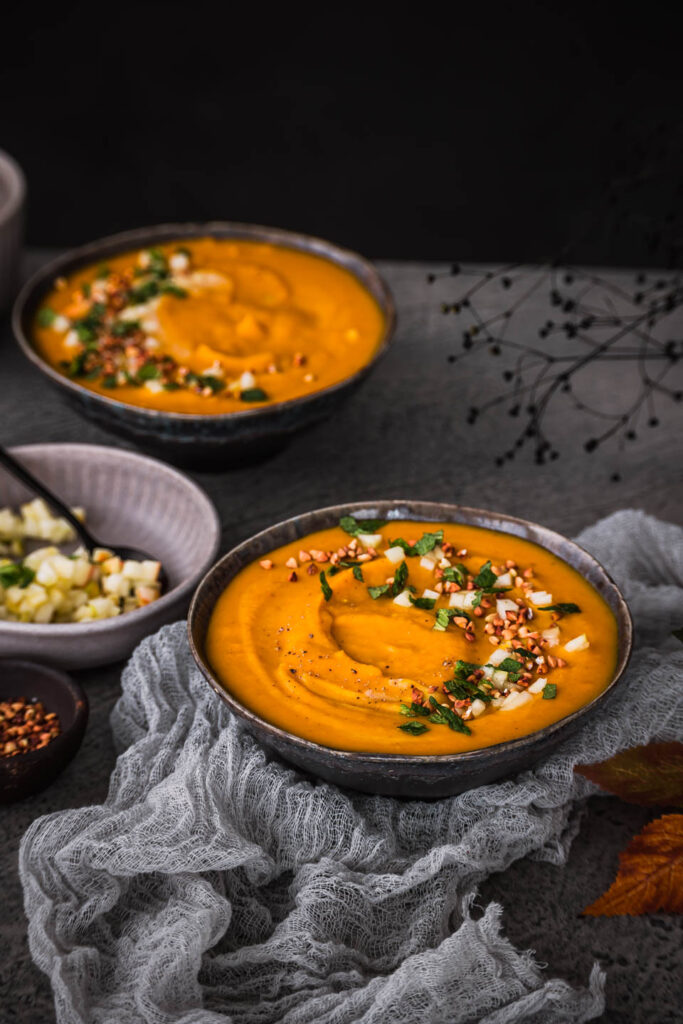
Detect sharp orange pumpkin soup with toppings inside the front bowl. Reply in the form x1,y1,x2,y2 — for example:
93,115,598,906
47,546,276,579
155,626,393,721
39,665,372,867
207,516,617,754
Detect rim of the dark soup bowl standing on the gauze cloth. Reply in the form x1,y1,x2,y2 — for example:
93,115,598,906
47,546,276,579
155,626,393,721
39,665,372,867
187,499,633,767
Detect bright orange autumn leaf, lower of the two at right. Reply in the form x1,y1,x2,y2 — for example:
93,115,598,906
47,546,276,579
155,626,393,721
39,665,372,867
584,814,683,918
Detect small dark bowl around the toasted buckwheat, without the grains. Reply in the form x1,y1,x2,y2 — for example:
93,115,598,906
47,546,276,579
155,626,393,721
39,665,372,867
0,658,88,804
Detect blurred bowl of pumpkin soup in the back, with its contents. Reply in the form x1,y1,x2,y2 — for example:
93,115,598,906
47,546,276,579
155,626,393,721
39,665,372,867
13,222,395,466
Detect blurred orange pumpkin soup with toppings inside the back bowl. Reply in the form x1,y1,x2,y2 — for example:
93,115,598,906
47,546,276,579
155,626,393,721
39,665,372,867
35,238,385,415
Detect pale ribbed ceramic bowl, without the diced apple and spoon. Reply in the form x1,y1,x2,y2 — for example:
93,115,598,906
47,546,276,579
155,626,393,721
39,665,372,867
0,444,220,669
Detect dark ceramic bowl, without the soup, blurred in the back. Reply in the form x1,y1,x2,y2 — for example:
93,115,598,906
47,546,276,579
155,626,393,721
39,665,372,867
12,221,396,468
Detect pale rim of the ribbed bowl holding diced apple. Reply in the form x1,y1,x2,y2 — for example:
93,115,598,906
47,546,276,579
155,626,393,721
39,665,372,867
0,441,221,634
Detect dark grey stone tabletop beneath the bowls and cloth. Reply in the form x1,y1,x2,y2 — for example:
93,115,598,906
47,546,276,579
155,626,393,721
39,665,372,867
0,254,683,1024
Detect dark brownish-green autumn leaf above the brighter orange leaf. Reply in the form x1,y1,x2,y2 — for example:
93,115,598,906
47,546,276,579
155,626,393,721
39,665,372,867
574,742,683,807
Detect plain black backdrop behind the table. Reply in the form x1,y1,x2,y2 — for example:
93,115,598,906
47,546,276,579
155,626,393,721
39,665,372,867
0,2,683,265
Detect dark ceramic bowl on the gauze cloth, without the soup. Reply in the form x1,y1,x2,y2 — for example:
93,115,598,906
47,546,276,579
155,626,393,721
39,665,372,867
188,501,633,798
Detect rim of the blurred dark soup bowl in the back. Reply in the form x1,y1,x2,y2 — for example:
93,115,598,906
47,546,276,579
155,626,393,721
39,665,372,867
11,220,397,425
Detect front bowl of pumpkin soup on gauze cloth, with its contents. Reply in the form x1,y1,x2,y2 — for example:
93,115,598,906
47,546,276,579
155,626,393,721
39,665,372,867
188,501,632,798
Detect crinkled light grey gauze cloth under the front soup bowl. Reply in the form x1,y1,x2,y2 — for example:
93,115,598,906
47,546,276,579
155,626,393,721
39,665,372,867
20,511,683,1024
